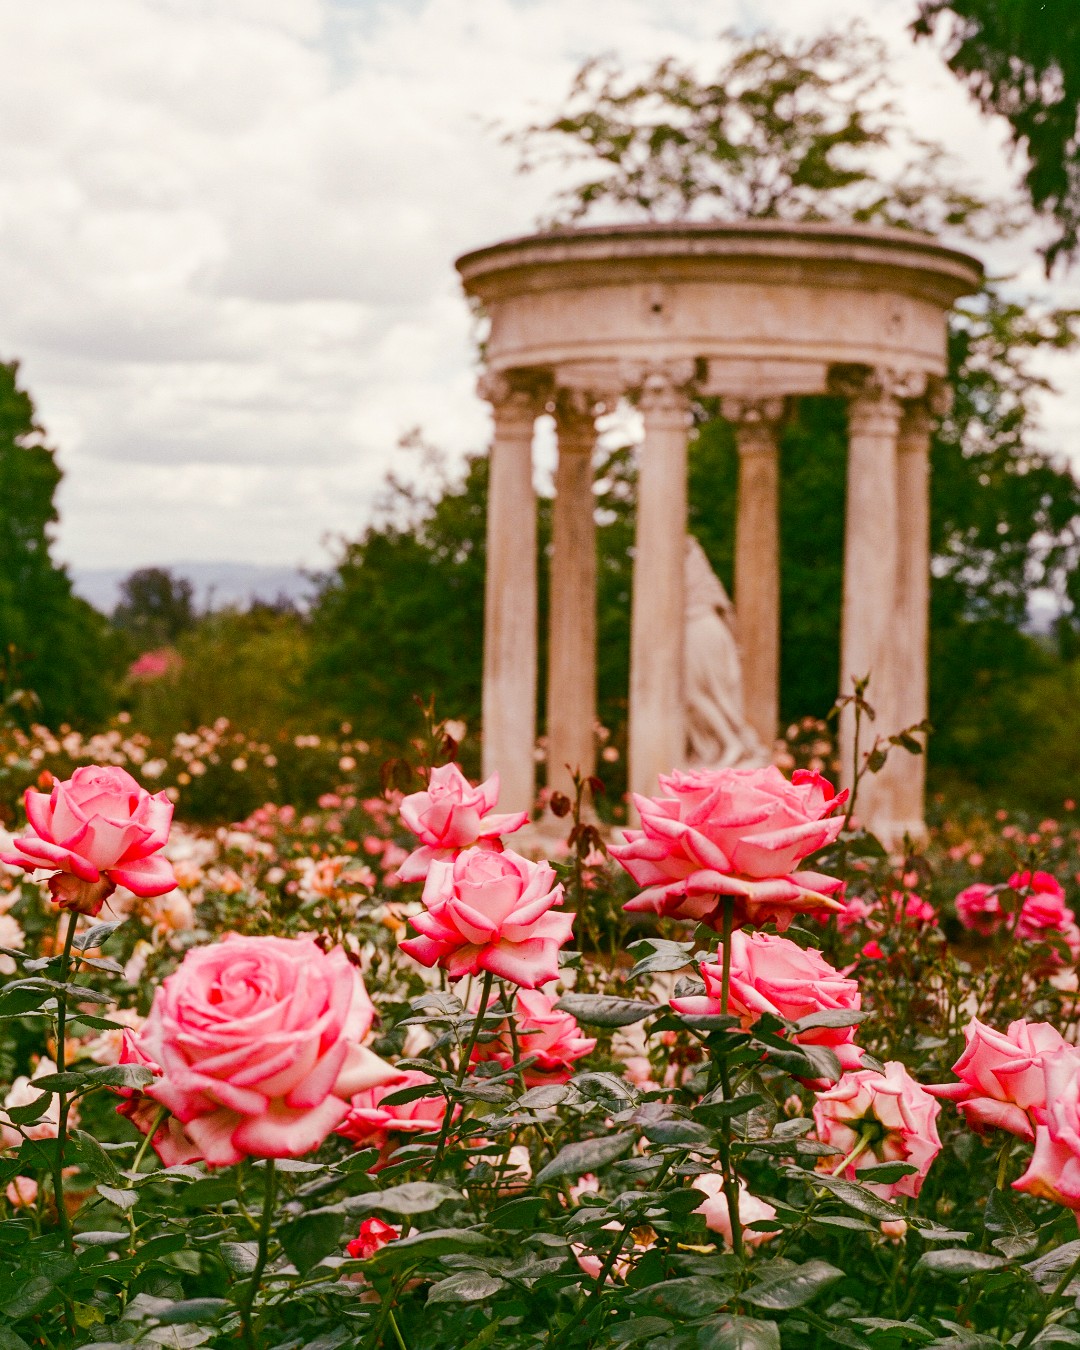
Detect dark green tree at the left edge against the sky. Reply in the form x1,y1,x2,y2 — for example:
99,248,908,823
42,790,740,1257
0,360,115,725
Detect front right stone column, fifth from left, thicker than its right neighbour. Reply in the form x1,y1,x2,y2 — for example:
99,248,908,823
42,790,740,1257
832,367,907,826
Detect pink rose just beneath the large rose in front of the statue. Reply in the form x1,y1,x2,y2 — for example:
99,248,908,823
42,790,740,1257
671,930,863,1069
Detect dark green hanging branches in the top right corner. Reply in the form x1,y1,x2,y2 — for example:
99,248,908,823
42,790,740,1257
913,0,1080,273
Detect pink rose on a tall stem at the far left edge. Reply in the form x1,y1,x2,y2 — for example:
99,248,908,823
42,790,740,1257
0,765,177,914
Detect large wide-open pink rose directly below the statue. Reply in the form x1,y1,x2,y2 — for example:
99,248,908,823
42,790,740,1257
612,765,846,929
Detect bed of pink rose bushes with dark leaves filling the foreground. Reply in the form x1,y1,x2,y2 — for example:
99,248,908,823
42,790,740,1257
0,764,1080,1350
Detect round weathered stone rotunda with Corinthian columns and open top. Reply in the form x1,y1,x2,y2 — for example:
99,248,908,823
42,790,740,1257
456,221,983,840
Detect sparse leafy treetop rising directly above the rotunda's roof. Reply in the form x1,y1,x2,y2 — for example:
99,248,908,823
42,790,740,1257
508,27,1007,231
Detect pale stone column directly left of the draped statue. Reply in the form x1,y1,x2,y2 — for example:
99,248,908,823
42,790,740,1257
629,362,694,797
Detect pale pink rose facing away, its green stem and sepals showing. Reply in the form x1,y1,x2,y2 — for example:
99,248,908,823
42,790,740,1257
814,1060,941,1200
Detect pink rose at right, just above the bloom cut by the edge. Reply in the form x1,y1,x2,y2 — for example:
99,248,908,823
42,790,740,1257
926,1018,1065,1139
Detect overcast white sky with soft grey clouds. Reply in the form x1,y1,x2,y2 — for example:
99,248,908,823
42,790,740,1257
0,0,1080,567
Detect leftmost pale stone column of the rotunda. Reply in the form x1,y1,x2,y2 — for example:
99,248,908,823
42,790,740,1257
479,375,543,811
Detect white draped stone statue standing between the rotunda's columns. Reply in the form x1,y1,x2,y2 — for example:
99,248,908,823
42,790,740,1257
686,535,770,768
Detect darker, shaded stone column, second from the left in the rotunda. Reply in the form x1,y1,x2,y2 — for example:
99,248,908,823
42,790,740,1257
547,390,597,794
